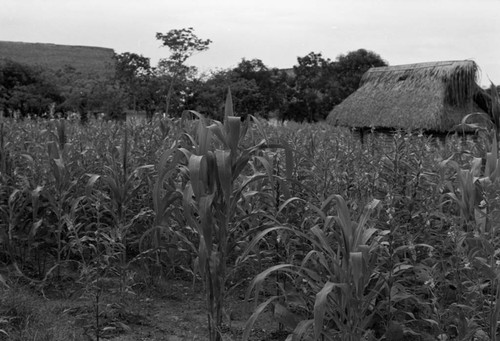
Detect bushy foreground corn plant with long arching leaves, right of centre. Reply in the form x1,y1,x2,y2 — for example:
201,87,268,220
243,195,385,340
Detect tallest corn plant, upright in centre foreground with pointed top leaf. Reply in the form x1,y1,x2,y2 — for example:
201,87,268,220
155,91,292,341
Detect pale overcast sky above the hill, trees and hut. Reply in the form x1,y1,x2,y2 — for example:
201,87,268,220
0,0,500,84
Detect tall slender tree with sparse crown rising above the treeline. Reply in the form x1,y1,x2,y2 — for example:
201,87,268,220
156,27,212,114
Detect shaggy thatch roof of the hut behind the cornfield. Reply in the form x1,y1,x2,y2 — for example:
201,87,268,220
327,60,483,132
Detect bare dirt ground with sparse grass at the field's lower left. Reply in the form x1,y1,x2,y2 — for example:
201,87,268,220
0,280,288,341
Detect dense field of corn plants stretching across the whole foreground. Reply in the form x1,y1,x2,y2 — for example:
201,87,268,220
0,91,500,340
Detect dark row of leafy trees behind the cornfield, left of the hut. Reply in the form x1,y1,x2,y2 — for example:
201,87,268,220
0,47,387,122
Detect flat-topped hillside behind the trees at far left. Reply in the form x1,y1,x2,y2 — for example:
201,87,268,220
0,41,114,78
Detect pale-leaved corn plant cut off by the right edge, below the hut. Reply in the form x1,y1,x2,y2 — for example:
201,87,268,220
445,151,500,340
